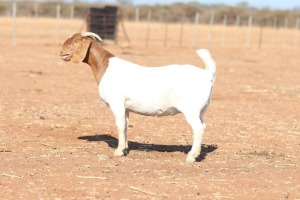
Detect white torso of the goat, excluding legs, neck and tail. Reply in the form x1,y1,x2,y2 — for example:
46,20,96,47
99,57,212,116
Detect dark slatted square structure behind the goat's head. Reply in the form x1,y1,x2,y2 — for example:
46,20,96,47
86,6,119,41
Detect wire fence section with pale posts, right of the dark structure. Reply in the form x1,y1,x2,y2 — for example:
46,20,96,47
130,8,300,48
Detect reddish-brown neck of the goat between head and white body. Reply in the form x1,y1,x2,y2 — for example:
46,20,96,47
83,42,114,85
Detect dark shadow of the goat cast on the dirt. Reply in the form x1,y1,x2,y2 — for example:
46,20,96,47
78,134,218,162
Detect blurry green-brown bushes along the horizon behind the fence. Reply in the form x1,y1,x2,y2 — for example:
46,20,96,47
0,0,300,27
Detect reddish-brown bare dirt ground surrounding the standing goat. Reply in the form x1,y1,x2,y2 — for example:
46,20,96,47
0,17,300,199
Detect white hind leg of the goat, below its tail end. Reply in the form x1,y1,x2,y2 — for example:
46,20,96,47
185,114,205,162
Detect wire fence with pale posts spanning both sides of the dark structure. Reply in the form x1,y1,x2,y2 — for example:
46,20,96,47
0,3,300,48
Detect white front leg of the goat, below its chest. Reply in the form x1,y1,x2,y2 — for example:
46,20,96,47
114,110,129,156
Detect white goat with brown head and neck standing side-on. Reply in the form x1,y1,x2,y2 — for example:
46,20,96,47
60,32,216,162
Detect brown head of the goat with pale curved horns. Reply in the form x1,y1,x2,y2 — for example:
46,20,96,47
60,32,102,63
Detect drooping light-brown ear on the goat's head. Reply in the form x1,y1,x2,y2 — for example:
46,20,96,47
71,37,91,63
